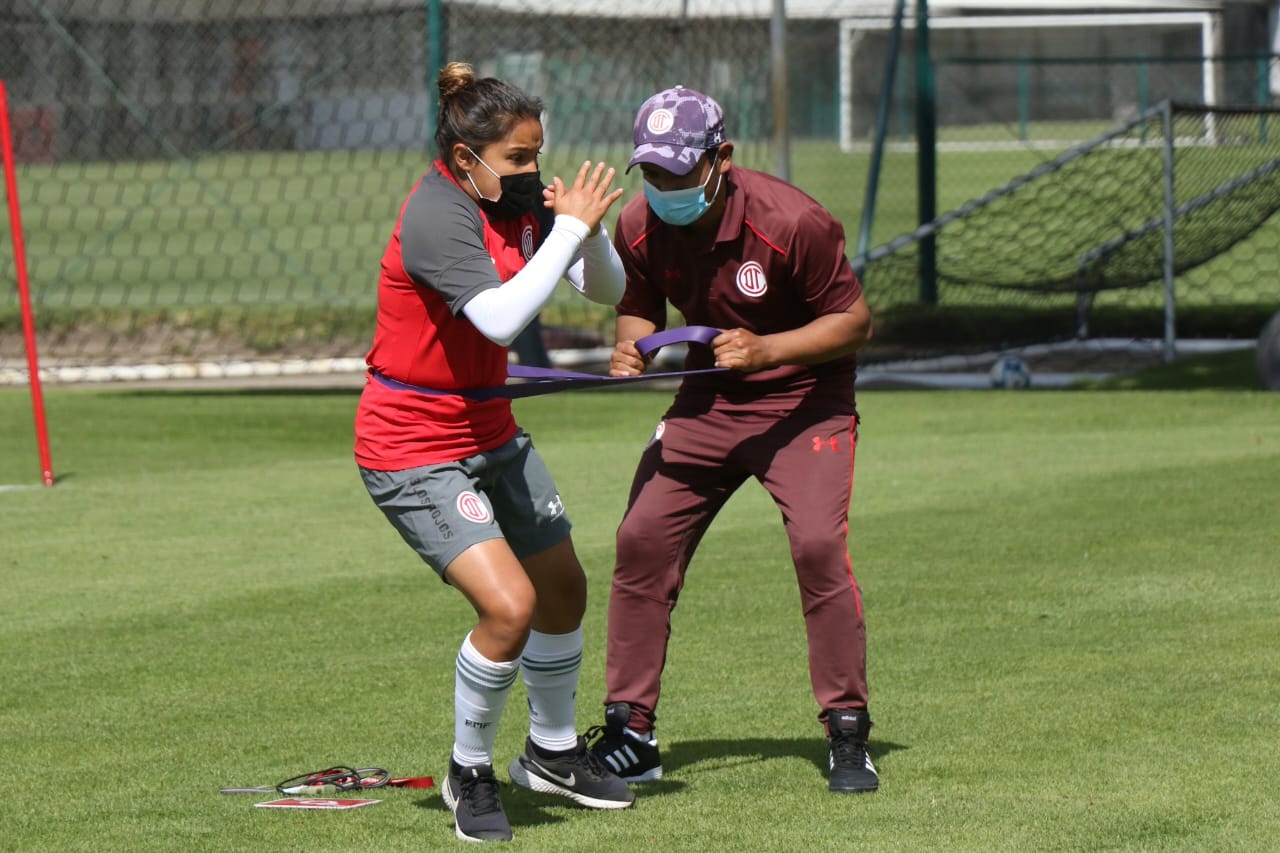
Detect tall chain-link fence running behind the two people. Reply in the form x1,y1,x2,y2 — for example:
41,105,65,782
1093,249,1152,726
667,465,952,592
0,0,1276,379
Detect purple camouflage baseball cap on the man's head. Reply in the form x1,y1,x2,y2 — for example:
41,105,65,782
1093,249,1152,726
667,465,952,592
627,86,724,174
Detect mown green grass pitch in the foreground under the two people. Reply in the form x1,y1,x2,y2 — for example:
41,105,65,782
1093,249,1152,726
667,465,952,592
0,363,1280,850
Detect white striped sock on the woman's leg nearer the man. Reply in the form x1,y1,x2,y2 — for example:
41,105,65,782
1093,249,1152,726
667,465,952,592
520,628,582,752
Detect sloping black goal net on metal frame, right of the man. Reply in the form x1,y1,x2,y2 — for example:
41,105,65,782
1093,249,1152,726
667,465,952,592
855,101,1280,348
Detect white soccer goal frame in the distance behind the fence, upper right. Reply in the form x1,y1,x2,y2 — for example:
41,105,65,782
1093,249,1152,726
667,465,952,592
837,12,1222,152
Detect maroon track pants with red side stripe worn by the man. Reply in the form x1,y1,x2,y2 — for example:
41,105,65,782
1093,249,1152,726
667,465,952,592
605,399,867,731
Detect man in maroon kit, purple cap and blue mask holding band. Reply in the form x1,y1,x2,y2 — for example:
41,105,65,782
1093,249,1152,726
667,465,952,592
583,86,879,793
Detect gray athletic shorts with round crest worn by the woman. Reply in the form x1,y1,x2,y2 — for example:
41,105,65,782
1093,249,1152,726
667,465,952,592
360,432,572,579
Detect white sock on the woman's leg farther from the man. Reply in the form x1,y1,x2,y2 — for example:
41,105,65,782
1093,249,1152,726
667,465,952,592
453,634,520,767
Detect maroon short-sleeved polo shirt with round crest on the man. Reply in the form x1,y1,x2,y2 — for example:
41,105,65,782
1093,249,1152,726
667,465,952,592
614,167,863,412
